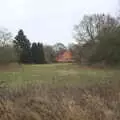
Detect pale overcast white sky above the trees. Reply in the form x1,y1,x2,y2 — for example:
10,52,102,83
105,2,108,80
0,0,119,45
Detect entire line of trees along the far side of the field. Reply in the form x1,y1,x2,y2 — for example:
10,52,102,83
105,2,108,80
0,14,120,66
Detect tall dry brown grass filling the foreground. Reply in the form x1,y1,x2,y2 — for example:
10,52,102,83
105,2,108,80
0,84,120,120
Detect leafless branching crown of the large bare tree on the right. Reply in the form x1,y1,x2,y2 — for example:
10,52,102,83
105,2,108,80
74,14,118,43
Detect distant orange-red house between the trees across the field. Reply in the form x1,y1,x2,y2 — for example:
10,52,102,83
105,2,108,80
56,51,73,62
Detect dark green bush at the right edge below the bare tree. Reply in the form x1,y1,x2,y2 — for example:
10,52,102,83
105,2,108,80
90,27,120,65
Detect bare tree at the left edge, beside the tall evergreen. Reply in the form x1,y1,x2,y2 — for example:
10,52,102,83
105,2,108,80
0,29,17,64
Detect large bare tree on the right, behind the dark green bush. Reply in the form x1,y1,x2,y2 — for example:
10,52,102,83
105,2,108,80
74,14,119,62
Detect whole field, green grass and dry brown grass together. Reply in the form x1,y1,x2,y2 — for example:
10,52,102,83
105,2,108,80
0,64,120,120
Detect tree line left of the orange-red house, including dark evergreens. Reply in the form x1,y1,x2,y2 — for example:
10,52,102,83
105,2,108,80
0,29,67,64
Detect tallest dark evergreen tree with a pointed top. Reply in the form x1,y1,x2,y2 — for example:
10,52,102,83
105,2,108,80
14,30,31,63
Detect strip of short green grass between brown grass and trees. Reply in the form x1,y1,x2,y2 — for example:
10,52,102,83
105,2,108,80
0,64,120,87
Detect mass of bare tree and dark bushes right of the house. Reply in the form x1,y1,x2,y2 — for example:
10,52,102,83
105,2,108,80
72,14,120,66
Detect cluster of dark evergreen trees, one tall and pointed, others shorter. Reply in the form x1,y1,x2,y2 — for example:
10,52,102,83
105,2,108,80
13,30,45,64
